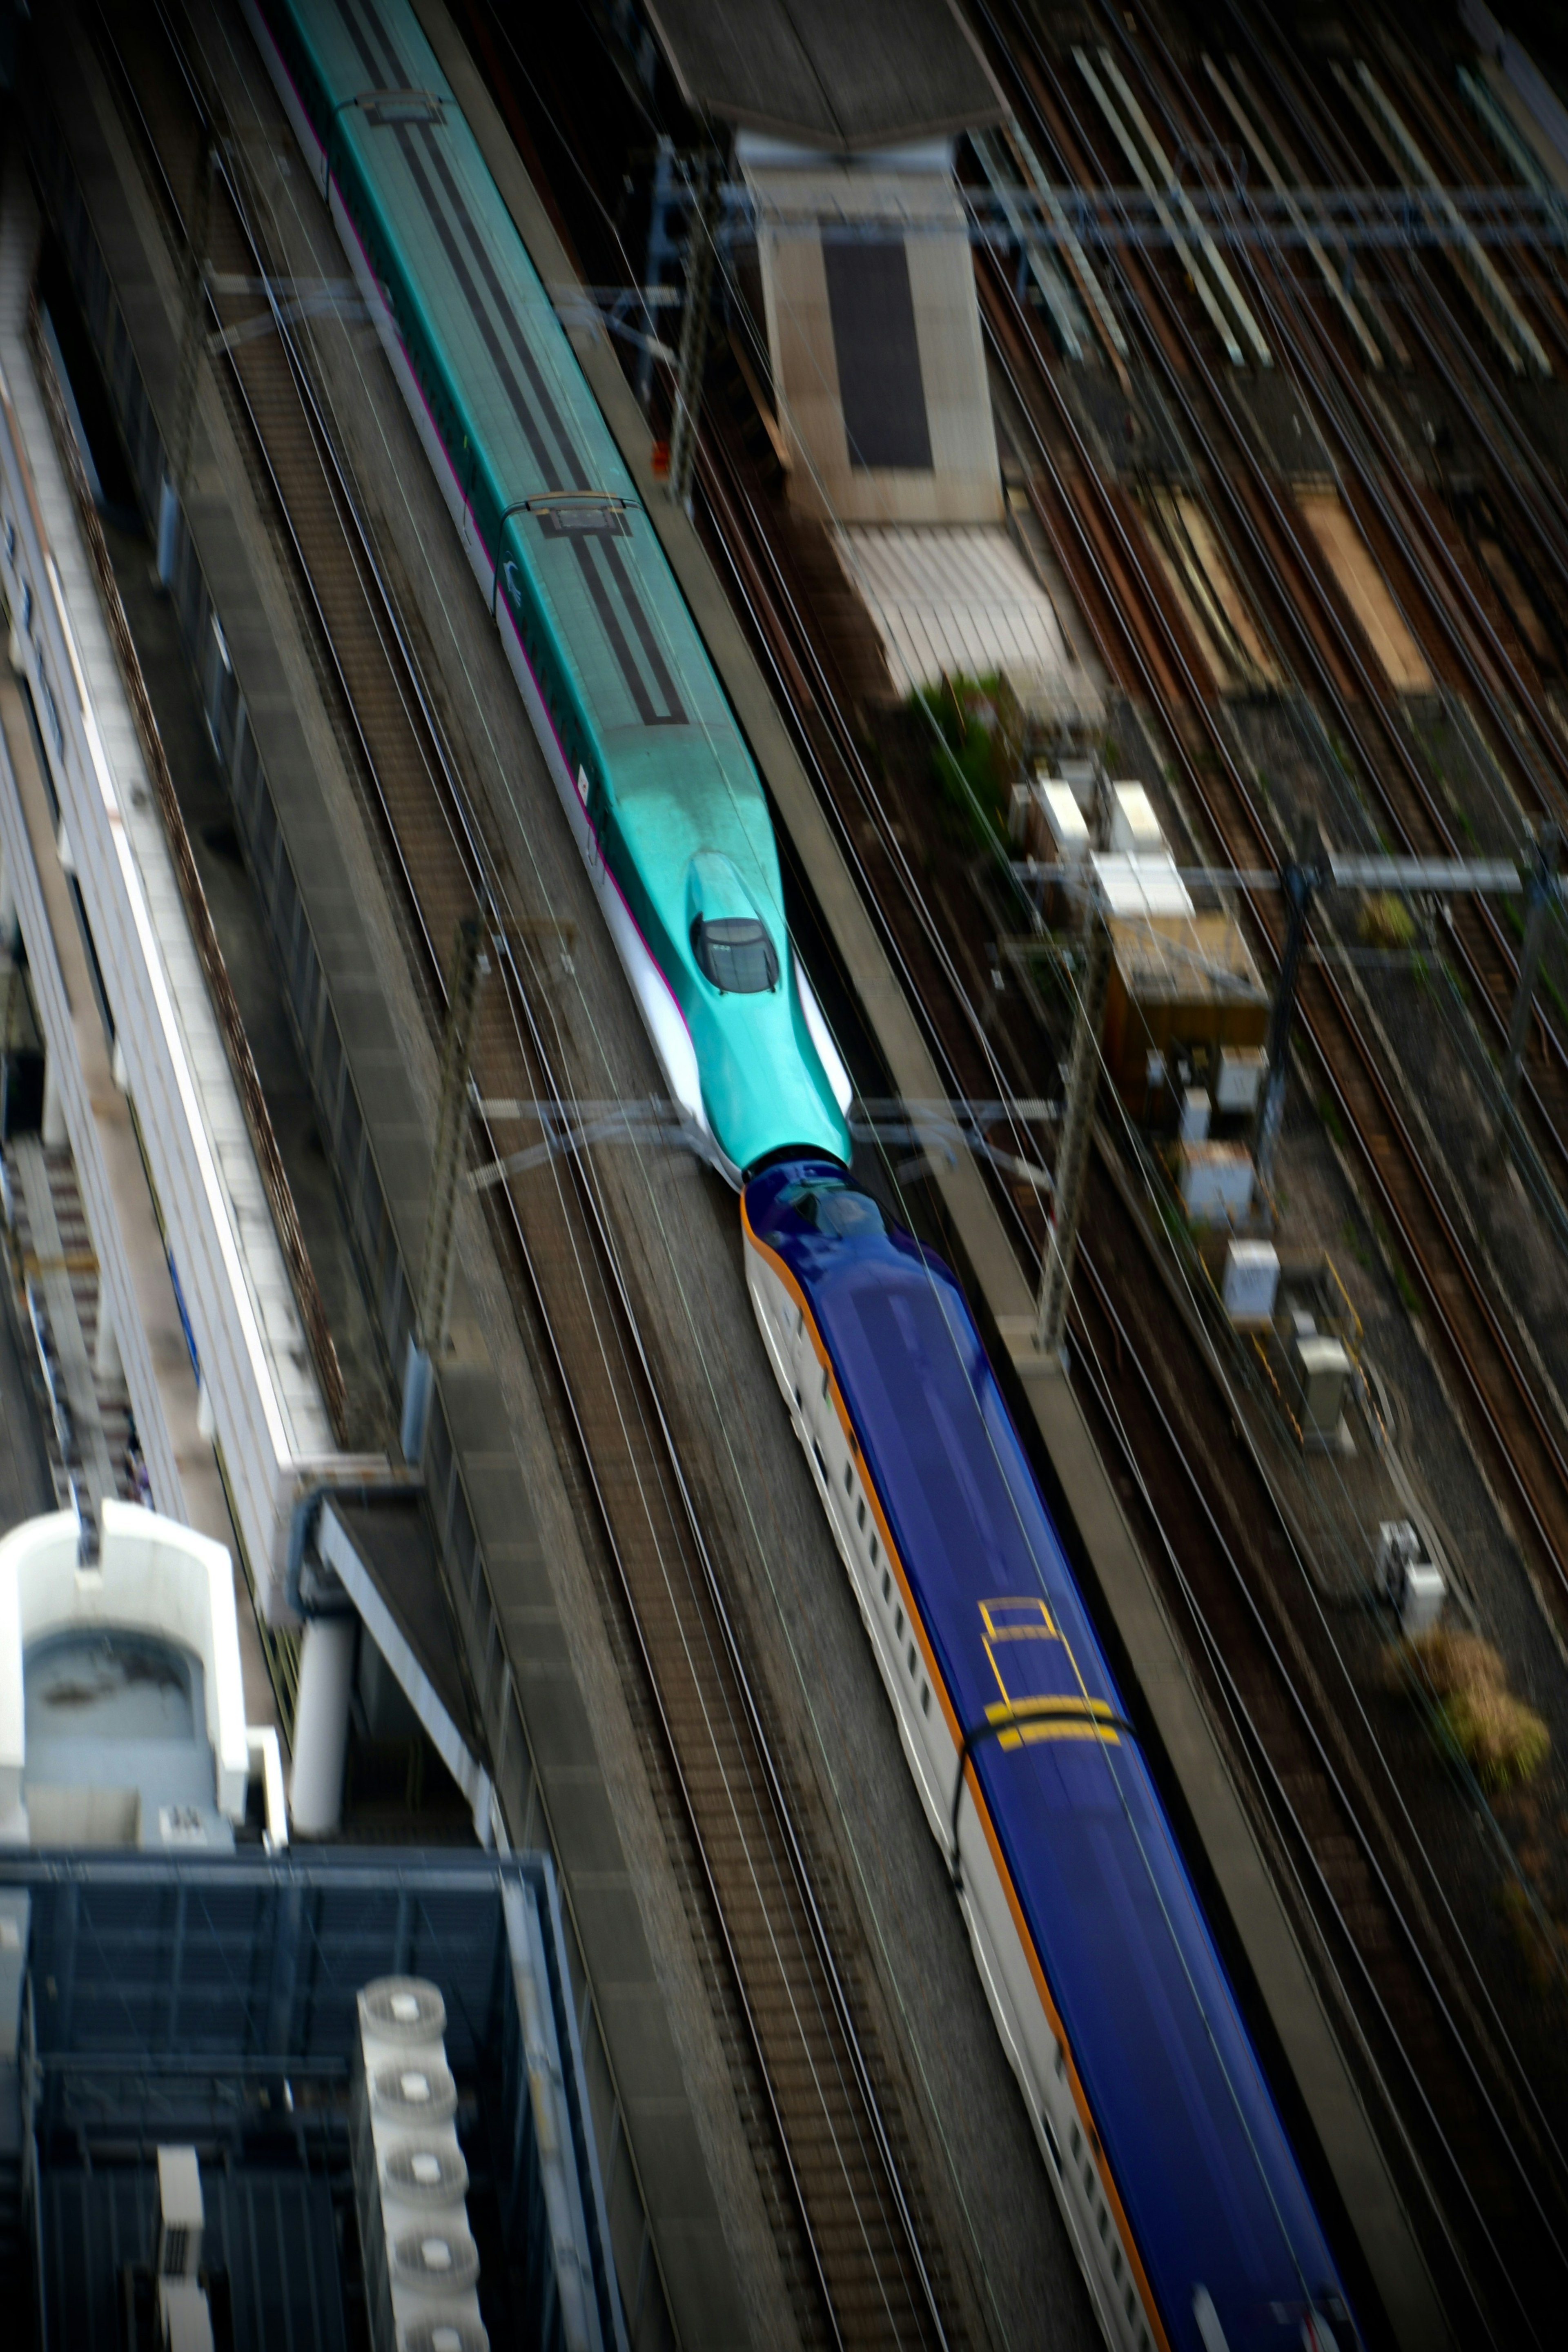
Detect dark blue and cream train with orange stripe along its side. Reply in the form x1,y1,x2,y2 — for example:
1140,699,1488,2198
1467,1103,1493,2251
740,1160,1350,2352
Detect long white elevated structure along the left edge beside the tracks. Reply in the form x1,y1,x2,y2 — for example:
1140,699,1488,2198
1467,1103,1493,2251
0,172,357,1613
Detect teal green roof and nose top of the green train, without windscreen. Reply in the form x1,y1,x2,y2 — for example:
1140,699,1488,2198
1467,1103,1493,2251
263,0,849,1169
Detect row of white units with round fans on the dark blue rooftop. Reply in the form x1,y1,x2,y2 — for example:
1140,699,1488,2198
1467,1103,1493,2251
350,1976,487,2352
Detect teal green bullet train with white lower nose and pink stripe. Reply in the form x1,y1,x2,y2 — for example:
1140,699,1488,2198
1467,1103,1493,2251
242,0,849,1183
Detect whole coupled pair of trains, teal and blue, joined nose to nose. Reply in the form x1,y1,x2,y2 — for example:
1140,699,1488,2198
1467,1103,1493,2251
242,0,1354,2352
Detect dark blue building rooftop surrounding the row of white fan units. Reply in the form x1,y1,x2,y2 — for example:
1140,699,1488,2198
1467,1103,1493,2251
0,1851,625,2352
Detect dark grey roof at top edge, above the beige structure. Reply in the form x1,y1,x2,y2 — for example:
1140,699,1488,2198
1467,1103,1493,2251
646,0,1004,153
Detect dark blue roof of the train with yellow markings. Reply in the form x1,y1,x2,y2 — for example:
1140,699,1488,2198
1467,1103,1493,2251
745,1162,1340,2352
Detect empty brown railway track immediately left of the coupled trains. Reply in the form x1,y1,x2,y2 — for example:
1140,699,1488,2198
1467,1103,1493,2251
95,0,943,2343
